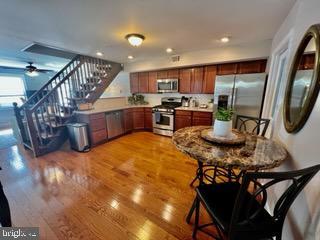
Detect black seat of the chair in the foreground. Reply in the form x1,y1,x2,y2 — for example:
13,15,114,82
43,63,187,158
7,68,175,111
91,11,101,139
196,182,272,233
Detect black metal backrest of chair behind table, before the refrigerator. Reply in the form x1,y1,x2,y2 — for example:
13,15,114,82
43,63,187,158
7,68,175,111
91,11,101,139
235,115,270,136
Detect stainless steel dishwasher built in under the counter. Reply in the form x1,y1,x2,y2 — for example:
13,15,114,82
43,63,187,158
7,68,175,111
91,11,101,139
106,111,124,139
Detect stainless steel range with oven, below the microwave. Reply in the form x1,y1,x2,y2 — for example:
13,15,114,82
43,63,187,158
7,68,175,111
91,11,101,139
152,97,182,136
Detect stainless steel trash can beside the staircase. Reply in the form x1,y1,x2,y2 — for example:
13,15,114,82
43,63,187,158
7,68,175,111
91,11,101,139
67,123,90,152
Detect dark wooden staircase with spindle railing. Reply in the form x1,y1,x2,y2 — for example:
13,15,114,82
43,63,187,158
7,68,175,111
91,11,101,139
13,55,122,157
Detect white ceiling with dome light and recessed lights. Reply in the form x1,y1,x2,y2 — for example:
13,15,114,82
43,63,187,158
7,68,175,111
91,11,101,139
0,0,295,68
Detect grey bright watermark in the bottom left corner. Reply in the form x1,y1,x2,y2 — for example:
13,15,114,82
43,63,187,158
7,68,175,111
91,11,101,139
0,227,40,240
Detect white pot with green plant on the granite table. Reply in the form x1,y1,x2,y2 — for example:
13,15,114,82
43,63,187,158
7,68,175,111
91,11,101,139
213,108,234,137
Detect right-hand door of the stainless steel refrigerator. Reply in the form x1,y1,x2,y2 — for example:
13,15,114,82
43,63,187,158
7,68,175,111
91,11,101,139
234,73,266,127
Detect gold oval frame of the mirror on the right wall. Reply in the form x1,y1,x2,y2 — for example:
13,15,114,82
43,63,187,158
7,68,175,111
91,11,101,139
283,24,320,133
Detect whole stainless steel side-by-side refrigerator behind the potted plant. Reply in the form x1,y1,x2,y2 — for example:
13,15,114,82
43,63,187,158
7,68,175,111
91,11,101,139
214,73,267,124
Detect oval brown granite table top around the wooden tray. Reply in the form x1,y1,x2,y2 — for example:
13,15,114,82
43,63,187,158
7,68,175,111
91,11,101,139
172,126,288,170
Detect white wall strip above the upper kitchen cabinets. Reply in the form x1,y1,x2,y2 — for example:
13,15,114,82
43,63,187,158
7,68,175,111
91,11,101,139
124,40,271,72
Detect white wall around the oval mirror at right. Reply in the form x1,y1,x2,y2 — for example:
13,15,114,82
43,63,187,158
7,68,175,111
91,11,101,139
265,0,320,240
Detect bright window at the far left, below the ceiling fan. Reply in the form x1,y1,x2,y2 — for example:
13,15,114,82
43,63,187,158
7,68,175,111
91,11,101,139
0,75,25,107
